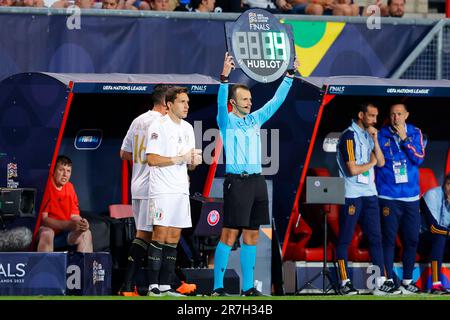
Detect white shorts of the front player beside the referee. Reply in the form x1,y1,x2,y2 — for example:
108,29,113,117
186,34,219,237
149,193,192,228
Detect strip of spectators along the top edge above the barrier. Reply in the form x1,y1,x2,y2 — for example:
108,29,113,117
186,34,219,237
0,0,406,17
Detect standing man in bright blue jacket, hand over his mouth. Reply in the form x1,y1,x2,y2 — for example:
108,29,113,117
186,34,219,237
376,103,425,294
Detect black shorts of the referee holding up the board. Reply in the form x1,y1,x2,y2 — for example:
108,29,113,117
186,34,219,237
223,174,270,230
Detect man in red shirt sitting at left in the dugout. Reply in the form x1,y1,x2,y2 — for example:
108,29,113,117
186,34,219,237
37,156,92,252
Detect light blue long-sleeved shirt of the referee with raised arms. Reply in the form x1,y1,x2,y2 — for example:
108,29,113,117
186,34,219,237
217,77,293,174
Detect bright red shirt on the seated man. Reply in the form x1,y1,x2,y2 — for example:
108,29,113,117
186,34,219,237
42,181,80,220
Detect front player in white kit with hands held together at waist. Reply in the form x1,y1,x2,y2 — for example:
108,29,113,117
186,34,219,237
146,87,202,296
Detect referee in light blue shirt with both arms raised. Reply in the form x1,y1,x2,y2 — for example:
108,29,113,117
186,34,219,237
212,52,298,296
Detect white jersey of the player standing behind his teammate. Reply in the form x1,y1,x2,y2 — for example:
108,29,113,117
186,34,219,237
121,110,162,199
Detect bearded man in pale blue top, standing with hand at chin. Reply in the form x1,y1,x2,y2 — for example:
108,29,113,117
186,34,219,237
336,102,401,295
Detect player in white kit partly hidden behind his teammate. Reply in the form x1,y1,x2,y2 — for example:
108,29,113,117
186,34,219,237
119,85,167,296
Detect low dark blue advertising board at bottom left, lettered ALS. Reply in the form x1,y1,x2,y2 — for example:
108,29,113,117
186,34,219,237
0,252,111,295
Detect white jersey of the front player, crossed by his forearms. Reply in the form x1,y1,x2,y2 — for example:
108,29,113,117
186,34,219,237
146,114,195,198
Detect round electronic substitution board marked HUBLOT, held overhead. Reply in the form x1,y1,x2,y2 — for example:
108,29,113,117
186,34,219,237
225,9,295,82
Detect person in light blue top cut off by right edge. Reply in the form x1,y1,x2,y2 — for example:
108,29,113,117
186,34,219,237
420,173,450,294
